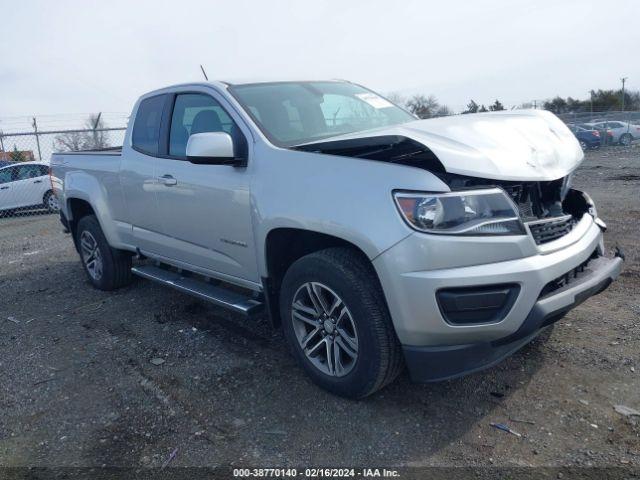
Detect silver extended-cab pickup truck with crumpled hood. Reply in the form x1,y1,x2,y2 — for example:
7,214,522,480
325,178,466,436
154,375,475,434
51,81,622,398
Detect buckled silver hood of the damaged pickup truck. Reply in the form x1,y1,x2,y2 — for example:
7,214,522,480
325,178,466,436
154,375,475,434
303,110,584,181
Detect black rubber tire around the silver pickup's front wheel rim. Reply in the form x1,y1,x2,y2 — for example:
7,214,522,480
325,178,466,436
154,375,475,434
280,248,403,398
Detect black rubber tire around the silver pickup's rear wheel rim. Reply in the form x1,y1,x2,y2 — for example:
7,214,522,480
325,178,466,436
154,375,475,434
76,215,132,291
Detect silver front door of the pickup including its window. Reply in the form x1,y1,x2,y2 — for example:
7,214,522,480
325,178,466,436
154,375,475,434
155,92,259,283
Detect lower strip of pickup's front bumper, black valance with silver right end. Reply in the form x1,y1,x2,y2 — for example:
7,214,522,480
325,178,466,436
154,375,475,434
403,251,622,382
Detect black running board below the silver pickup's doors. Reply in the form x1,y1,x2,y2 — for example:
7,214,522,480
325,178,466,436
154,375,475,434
131,265,264,317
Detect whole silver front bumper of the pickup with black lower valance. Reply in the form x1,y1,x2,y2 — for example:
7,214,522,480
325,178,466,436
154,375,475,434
373,214,622,381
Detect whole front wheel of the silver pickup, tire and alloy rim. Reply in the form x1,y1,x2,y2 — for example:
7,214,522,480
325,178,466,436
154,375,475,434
280,248,402,398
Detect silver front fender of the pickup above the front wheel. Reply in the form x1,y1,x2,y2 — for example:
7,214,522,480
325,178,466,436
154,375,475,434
251,146,449,276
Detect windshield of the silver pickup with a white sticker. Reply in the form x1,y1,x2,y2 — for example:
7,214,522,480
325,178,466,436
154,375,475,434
229,82,415,147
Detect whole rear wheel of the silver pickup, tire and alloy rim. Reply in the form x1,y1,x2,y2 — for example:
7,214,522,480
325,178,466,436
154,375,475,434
76,215,131,290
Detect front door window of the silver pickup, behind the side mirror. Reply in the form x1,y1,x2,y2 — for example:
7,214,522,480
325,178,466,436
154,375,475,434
169,93,235,157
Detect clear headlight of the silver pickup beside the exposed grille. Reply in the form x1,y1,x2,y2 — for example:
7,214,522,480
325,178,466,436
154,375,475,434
393,188,526,235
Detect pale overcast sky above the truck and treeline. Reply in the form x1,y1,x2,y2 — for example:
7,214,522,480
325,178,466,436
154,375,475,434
0,0,640,128
